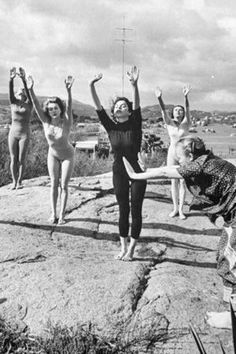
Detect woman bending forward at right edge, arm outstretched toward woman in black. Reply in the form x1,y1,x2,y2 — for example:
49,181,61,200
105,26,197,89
122,136,236,327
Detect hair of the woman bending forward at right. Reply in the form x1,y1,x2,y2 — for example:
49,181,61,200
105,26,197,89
177,135,207,159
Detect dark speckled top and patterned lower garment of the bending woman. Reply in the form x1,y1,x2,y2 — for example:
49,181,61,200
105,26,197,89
178,151,236,288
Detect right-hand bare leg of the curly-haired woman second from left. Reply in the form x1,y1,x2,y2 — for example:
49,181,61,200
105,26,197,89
58,157,74,224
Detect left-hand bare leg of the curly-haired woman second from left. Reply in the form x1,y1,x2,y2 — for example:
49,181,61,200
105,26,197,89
48,152,60,223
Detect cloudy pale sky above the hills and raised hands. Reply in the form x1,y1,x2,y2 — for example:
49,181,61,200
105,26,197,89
0,0,236,111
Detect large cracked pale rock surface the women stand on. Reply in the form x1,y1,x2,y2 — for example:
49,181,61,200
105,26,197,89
0,174,233,354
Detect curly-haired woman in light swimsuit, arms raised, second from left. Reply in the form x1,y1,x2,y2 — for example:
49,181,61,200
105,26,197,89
27,76,74,224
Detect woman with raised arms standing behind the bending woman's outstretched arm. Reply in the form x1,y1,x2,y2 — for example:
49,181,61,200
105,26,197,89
155,86,191,220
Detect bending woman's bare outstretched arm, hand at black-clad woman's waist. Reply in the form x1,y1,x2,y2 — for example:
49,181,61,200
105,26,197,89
123,157,182,179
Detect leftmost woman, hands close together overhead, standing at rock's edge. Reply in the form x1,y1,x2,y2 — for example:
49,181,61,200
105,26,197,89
8,67,33,189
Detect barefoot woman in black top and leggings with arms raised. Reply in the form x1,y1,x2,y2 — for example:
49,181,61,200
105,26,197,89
90,66,146,261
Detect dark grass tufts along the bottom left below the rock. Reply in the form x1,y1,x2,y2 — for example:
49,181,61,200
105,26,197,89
0,319,170,354
